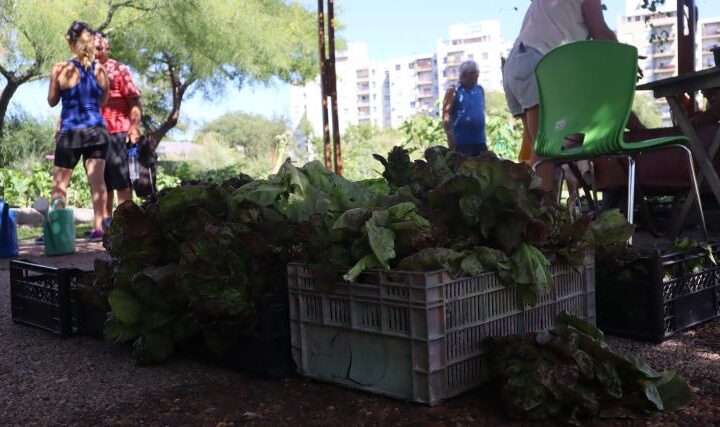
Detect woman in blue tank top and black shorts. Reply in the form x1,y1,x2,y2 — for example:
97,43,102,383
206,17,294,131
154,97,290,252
48,21,110,240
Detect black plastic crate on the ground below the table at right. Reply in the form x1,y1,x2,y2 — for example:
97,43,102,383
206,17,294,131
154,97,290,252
596,243,720,342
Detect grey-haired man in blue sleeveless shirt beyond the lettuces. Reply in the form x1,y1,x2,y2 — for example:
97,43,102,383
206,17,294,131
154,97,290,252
443,61,487,156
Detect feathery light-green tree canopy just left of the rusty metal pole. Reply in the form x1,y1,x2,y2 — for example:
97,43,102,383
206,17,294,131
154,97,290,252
108,0,317,140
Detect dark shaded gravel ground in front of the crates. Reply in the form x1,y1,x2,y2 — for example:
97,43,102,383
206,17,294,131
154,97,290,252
0,243,720,426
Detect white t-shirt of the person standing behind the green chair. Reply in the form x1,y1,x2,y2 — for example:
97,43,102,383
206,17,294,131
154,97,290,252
515,0,589,55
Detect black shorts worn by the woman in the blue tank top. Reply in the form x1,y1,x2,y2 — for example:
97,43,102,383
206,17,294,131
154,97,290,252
53,126,110,169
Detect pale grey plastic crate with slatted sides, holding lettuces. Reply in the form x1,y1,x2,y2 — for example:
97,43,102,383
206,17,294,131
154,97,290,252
288,252,595,405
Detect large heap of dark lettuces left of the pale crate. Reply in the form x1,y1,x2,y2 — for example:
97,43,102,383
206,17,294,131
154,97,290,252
102,162,371,363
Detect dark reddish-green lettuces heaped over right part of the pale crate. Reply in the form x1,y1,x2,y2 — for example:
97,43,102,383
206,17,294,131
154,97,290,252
372,147,632,305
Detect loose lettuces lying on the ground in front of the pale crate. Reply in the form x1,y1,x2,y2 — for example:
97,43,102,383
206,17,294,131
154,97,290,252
483,312,693,425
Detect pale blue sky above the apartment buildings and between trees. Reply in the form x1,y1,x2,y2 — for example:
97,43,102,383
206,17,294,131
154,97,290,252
12,0,720,139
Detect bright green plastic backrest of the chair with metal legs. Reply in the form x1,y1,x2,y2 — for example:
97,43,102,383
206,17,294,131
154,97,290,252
535,41,637,158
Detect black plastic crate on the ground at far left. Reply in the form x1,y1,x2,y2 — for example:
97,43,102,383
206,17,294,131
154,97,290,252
10,260,91,337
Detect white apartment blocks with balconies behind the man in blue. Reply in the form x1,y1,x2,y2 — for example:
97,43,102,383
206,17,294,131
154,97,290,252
290,21,507,135
